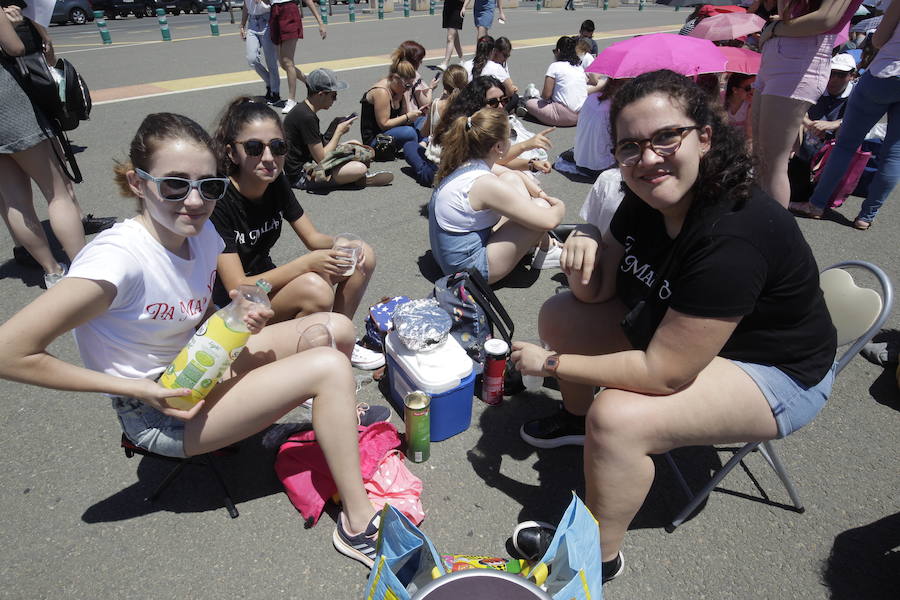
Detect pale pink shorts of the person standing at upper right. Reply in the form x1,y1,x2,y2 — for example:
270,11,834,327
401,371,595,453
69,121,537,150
754,34,835,104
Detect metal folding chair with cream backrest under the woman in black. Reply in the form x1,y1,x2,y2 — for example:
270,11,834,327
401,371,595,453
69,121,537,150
665,260,894,533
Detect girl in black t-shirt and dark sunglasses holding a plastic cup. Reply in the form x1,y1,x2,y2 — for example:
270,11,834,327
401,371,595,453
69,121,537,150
210,98,384,369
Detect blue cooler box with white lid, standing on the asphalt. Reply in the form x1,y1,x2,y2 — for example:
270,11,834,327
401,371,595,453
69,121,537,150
385,331,475,442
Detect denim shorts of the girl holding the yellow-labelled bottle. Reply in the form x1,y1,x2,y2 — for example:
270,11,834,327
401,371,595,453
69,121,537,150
112,396,186,458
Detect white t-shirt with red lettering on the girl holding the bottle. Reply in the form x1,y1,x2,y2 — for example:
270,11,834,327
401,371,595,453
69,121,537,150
67,219,225,379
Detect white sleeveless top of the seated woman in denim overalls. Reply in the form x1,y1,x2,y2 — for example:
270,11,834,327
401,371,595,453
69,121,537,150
434,160,500,233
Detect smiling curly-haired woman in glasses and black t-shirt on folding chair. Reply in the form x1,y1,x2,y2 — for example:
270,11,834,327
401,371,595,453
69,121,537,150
511,71,836,580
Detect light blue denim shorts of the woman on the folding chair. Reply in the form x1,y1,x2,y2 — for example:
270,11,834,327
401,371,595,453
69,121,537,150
731,360,837,438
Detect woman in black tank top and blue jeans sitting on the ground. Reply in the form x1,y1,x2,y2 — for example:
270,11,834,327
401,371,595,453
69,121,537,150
359,60,428,155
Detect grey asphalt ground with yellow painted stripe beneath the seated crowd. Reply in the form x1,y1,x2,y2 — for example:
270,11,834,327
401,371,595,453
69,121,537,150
0,3,900,600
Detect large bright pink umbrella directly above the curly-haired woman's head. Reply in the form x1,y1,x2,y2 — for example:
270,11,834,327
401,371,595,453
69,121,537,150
586,33,726,79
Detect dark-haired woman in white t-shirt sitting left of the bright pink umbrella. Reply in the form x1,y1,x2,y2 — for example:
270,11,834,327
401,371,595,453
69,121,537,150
525,35,588,127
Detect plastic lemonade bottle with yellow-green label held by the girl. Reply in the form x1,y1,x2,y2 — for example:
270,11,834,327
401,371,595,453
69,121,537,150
159,279,272,410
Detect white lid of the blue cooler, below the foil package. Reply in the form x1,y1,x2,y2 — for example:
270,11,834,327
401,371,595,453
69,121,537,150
386,331,473,394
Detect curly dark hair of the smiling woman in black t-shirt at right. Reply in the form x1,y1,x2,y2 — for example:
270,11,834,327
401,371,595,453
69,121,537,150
609,70,753,213
